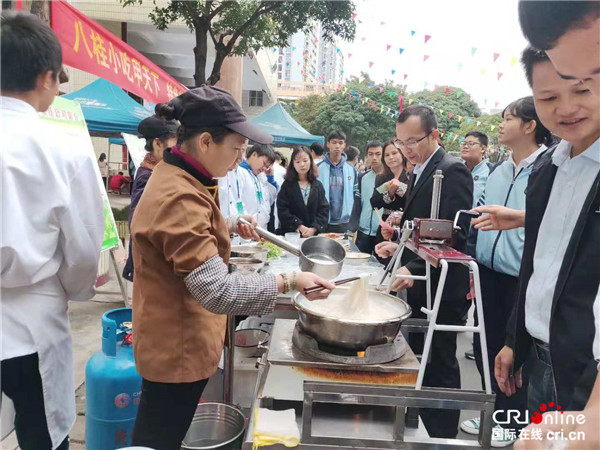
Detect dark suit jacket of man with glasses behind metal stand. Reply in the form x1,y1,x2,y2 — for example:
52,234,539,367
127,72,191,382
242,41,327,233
402,148,473,311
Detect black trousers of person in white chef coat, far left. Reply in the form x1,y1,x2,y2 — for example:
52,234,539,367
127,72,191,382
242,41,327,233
1,353,69,450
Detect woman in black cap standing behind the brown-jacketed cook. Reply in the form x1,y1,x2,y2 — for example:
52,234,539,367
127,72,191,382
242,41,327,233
123,115,179,281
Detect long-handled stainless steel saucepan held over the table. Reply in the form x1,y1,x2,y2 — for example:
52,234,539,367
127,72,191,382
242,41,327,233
240,219,346,280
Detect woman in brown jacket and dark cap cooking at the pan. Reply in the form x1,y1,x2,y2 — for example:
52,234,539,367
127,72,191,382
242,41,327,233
131,86,335,450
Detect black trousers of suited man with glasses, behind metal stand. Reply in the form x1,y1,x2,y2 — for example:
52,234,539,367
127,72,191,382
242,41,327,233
408,298,470,439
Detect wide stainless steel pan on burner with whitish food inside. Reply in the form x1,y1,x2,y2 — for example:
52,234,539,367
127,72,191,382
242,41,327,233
293,287,412,351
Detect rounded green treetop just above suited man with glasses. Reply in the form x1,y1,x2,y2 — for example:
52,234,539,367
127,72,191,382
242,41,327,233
409,86,481,132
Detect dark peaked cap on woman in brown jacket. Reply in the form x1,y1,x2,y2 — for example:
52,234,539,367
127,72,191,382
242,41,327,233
156,85,273,144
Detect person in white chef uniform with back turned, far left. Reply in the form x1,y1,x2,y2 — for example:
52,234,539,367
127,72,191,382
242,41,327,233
0,12,104,450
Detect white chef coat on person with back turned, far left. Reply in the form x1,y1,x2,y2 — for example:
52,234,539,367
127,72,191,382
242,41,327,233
0,97,104,448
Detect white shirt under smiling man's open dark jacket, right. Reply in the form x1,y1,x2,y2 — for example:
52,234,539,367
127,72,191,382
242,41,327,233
525,139,600,343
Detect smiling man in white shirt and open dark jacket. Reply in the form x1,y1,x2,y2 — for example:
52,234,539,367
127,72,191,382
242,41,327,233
488,49,600,416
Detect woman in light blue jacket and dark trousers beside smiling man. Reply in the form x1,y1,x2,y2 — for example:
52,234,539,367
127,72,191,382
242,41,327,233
460,97,553,446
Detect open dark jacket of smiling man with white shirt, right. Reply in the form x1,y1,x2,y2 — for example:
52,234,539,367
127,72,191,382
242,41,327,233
506,149,600,411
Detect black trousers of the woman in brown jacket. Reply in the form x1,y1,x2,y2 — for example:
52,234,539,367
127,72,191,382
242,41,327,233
131,379,208,450
